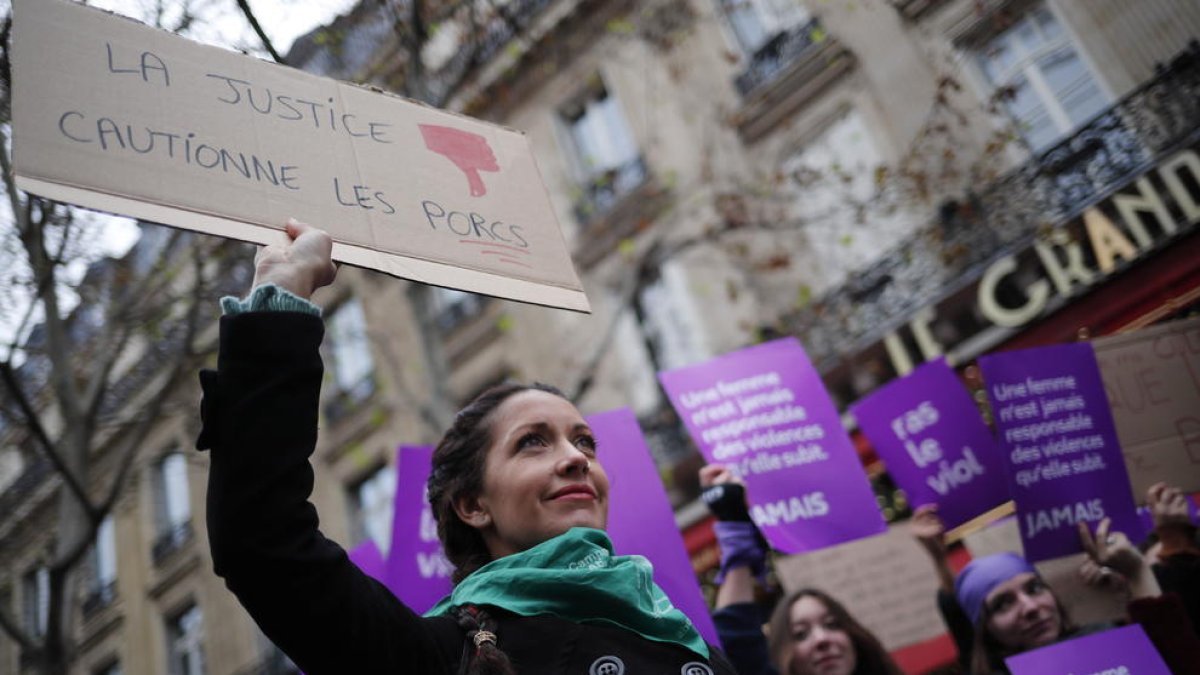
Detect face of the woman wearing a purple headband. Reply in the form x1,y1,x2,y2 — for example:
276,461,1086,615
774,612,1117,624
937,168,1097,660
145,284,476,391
984,572,1062,651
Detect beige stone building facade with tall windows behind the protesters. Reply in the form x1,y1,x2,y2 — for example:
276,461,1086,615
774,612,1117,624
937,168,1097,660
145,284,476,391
0,0,1200,675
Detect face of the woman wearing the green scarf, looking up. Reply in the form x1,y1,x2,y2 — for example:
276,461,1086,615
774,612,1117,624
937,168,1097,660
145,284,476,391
455,390,608,557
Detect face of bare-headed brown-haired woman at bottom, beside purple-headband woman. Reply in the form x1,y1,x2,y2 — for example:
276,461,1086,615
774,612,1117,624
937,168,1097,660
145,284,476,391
788,596,858,675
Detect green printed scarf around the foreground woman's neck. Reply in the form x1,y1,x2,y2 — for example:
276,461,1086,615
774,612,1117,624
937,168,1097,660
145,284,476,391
425,527,708,659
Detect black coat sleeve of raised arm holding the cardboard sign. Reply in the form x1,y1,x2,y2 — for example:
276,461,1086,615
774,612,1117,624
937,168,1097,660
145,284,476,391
197,312,461,675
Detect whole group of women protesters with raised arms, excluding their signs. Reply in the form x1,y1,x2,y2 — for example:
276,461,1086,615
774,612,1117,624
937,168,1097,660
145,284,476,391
198,222,1200,675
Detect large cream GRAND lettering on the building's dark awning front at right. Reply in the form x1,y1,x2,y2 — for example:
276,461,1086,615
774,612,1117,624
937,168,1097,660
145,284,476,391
884,148,1200,372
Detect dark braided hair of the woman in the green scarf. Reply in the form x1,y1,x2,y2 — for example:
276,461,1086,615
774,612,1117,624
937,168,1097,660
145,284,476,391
425,382,566,675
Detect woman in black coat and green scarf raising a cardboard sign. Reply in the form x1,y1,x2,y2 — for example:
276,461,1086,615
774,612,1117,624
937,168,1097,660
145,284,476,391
197,222,733,675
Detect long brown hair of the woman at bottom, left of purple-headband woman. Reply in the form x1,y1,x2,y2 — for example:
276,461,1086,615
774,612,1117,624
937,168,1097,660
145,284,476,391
768,589,904,675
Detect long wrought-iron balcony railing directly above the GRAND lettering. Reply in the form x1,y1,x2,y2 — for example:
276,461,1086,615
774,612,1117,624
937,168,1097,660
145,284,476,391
785,46,1200,371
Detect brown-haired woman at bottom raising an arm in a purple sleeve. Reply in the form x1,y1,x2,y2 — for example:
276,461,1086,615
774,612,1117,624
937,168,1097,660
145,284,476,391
700,465,901,675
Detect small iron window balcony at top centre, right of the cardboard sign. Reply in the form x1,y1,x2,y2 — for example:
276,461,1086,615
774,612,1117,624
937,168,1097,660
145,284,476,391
733,19,854,142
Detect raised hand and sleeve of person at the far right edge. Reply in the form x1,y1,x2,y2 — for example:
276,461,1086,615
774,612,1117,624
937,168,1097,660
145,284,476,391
1146,483,1200,624
